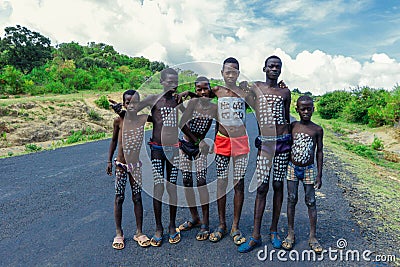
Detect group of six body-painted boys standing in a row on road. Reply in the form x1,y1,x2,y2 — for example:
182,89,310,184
107,56,323,253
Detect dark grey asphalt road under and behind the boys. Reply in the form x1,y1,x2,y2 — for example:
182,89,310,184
0,115,374,266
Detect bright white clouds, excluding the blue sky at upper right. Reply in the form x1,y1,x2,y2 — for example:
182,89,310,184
0,0,400,94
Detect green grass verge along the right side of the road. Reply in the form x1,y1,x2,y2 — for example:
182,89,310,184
313,115,400,252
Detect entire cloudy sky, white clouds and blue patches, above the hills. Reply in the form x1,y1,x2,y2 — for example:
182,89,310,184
0,0,400,94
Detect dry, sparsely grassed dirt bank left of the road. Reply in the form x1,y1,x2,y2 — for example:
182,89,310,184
0,93,121,156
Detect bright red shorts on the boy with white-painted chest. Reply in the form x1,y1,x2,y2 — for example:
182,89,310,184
214,132,250,157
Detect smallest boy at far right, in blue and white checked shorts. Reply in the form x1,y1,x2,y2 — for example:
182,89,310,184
282,96,324,253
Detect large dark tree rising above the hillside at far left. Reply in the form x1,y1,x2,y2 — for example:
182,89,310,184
0,25,52,74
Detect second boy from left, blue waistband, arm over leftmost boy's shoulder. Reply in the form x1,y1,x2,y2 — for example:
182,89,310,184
134,68,181,247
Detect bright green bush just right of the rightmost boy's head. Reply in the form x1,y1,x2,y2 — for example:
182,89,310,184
316,91,351,119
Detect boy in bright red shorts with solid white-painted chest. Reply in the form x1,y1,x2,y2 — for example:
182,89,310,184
209,57,250,245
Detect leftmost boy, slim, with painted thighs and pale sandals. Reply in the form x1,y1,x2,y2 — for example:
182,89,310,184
106,90,150,249
